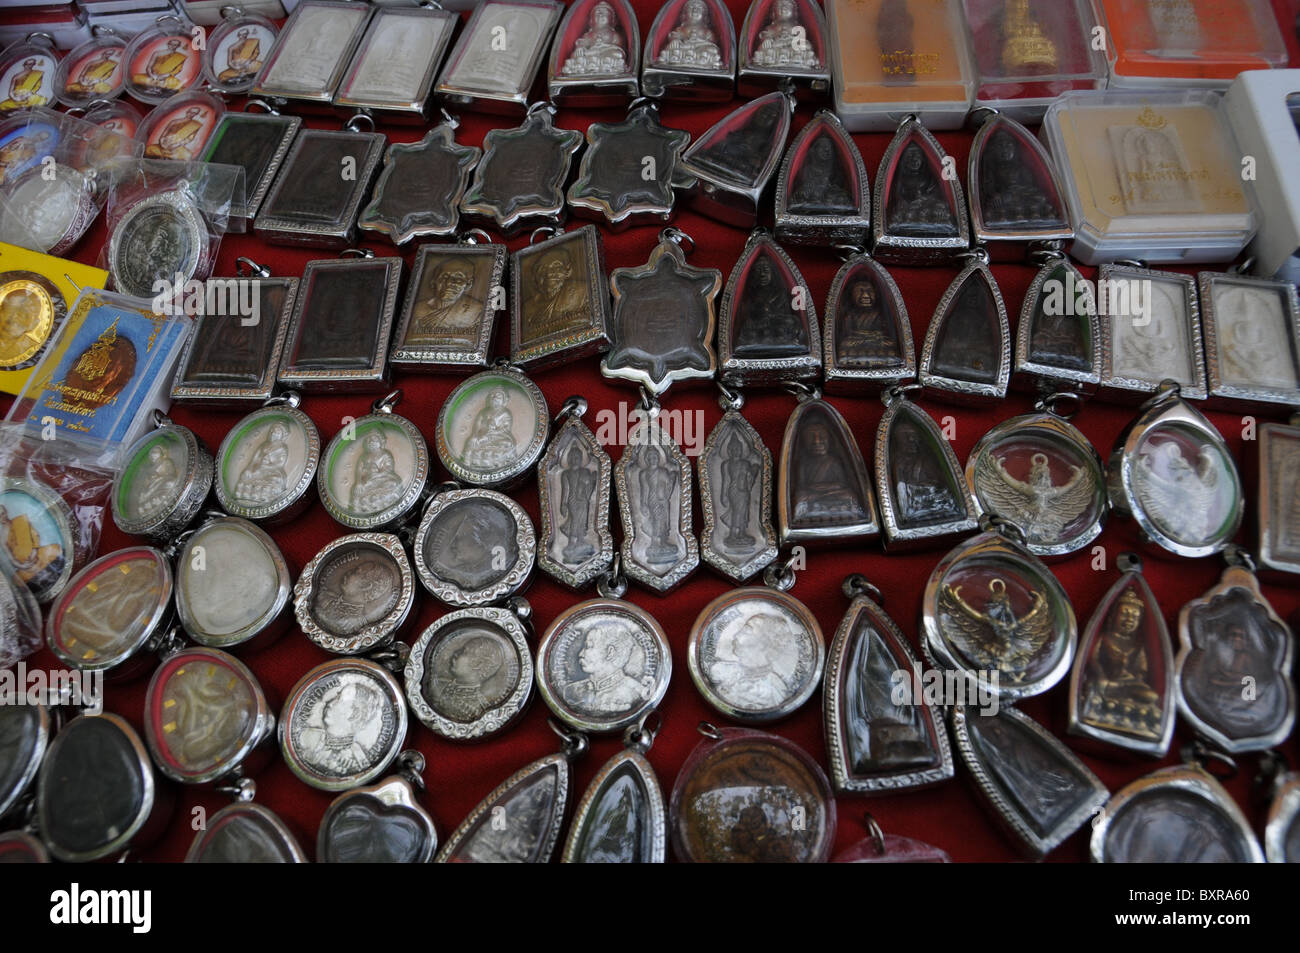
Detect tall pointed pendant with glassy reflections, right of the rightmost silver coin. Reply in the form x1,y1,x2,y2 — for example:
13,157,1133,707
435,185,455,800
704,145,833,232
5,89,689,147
822,576,953,794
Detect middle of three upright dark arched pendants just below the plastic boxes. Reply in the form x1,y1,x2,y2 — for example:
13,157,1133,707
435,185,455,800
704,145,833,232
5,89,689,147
871,117,970,264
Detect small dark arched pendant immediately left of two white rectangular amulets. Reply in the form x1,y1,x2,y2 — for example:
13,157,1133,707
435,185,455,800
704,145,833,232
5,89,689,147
1013,256,1101,394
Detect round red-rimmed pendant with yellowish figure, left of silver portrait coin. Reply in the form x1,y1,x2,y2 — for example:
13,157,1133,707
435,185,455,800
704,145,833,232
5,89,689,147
144,647,276,784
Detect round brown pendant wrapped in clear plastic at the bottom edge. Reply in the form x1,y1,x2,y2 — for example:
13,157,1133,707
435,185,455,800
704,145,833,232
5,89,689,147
668,724,835,863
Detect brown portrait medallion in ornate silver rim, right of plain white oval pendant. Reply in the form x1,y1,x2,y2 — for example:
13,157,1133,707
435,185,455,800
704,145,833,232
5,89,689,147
294,533,415,655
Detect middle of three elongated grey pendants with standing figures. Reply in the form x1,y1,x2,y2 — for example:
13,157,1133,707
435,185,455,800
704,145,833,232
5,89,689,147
614,417,699,593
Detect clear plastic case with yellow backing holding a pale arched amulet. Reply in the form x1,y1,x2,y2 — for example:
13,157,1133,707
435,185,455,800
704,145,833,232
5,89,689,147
1040,90,1258,264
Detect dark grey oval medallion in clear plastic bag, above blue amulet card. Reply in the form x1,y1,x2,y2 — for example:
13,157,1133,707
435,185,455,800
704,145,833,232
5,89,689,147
108,190,211,299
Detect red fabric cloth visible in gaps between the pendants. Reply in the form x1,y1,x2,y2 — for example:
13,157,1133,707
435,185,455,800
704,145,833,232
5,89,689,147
10,0,1300,861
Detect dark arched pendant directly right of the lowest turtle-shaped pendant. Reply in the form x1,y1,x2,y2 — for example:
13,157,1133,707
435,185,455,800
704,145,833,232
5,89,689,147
718,229,822,385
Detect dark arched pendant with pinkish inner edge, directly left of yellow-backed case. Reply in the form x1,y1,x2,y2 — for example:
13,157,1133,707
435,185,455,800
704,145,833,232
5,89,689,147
966,114,1074,244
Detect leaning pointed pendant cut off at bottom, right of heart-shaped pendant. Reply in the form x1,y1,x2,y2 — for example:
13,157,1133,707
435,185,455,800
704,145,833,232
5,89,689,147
434,723,588,863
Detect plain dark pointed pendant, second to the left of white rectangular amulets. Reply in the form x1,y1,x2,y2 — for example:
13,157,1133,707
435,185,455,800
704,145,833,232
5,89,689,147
919,250,1011,403
